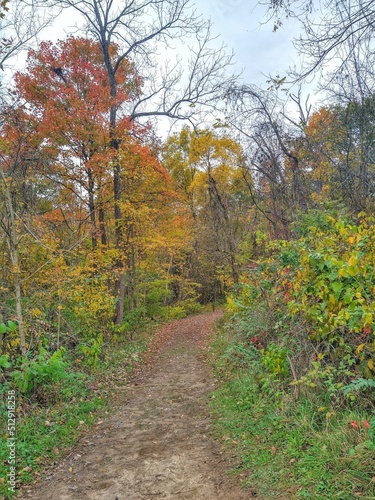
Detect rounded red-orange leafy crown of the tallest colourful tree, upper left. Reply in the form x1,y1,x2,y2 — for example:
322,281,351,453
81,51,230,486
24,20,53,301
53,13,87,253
16,37,140,146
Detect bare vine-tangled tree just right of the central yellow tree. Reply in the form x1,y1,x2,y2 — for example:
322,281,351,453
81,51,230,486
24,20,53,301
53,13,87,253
228,85,309,237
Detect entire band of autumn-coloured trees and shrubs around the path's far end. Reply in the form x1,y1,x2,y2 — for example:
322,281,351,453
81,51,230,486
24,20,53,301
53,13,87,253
0,33,375,424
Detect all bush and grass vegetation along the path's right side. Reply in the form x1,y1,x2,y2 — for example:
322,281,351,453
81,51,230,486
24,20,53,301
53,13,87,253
212,213,375,500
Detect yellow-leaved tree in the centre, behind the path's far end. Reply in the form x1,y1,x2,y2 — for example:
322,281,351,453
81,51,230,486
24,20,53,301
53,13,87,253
164,128,251,302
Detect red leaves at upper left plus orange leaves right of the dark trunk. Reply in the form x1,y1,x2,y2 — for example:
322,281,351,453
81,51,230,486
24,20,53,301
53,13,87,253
12,37,163,239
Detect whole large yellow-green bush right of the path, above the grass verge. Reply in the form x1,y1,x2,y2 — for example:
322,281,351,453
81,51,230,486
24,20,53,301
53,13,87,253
228,212,375,394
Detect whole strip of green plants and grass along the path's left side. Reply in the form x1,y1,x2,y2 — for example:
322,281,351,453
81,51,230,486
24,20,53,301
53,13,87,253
0,324,152,499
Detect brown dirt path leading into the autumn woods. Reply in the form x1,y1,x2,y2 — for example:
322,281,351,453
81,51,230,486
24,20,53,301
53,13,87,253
22,313,253,500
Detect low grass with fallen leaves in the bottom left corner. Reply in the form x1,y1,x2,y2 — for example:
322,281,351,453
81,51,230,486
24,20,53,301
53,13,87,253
0,373,105,498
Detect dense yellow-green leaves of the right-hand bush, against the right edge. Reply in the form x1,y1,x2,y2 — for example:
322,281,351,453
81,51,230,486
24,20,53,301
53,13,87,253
288,213,375,377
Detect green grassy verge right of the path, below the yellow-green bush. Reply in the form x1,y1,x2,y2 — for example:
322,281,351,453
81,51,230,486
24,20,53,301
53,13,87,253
211,312,375,500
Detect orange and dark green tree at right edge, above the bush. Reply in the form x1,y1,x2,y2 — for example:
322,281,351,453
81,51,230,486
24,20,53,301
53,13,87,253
301,98,375,214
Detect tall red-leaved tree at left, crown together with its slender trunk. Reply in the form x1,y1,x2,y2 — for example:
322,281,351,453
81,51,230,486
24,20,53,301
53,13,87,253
16,37,142,248
